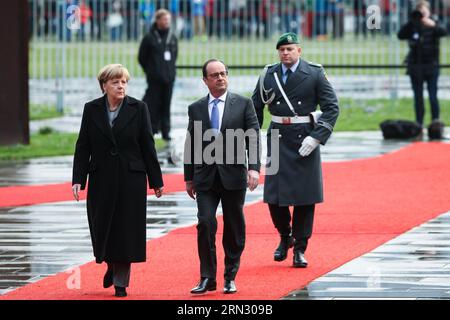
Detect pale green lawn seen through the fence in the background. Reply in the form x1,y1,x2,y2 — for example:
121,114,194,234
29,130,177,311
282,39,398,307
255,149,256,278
29,35,450,78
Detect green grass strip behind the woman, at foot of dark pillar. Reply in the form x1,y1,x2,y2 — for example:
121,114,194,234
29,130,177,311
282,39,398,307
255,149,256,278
0,132,166,160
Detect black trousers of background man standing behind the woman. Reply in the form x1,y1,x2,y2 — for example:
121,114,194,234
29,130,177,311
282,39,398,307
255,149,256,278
142,82,173,140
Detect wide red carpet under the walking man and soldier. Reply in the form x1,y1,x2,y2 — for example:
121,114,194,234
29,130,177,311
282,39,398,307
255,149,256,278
0,143,450,299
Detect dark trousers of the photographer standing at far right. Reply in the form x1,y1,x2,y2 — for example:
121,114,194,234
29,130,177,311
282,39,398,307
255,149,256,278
408,65,439,125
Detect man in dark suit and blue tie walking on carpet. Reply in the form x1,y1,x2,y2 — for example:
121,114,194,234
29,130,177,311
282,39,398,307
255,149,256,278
184,59,260,294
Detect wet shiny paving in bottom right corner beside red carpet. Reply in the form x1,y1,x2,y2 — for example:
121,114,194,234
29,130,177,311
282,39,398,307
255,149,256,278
285,212,450,300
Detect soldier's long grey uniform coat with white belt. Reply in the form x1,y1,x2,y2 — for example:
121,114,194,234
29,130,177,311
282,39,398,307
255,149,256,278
252,59,339,206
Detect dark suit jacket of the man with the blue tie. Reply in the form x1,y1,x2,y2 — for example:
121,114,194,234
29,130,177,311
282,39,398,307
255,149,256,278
184,92,261,191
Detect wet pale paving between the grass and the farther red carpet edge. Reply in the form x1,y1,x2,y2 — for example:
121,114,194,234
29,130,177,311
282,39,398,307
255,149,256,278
0,129,424,187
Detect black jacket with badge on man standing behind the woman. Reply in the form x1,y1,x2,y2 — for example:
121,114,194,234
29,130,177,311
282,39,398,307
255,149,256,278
138,24,178,84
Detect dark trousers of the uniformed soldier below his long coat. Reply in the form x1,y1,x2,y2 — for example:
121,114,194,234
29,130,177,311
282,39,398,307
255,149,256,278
269,204,316,253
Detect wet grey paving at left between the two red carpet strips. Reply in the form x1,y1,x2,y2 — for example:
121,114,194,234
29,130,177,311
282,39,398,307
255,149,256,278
0,187,262,294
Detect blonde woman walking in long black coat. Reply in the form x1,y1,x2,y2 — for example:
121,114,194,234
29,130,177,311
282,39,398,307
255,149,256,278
72,64,163,297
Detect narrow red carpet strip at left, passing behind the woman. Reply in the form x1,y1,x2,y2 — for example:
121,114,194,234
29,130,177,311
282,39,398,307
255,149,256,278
0,174,185,208
